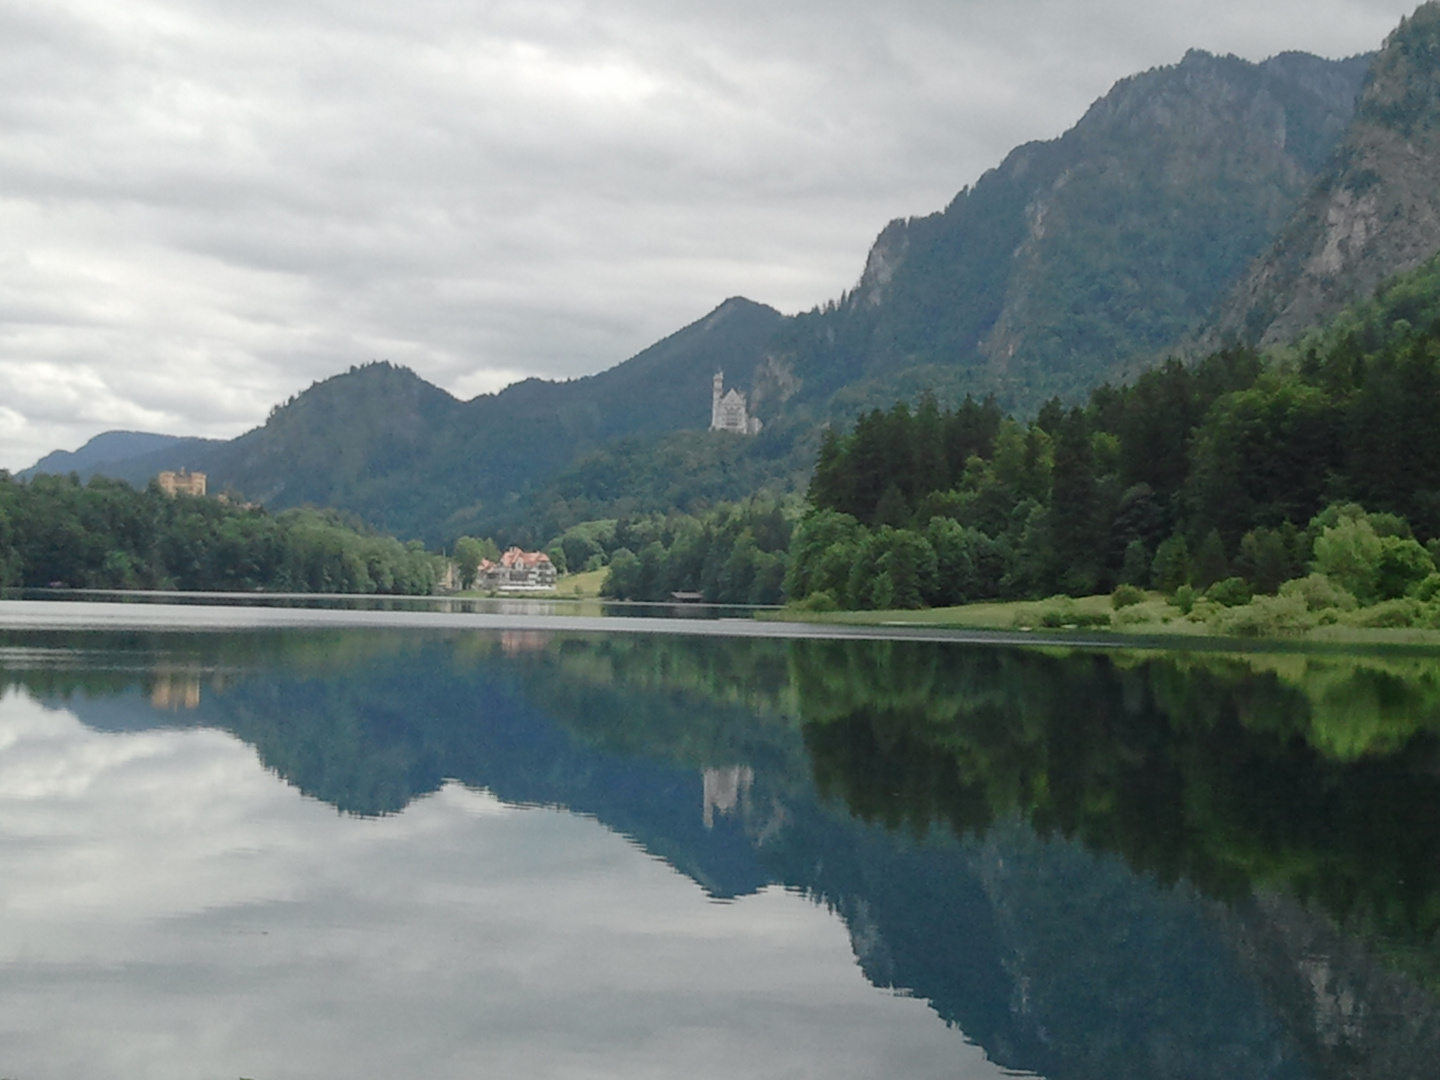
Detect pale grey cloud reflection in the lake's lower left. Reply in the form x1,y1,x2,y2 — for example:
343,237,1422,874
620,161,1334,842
0,690,1001,1080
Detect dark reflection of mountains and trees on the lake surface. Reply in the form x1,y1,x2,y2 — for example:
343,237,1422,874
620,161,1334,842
0,632,1440,1080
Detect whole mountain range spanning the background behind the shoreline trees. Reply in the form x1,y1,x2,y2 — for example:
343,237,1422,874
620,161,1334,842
27,3,1440,543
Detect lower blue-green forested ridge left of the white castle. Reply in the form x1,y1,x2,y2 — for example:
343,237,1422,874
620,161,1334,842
180,298,782,543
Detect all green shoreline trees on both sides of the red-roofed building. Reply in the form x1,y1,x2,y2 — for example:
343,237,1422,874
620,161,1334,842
8,261,1440,635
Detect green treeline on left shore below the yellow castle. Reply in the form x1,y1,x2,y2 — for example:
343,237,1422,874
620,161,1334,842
0,472,439,595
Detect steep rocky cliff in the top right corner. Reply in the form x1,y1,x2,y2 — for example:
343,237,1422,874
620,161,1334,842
1201,3,1440,348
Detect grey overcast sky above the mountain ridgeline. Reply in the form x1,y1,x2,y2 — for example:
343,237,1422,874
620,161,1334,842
0,0,1416,469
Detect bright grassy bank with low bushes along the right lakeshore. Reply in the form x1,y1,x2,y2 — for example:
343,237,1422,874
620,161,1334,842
756,593,1440,648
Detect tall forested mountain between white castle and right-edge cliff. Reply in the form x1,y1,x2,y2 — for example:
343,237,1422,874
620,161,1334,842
776,52,1368,409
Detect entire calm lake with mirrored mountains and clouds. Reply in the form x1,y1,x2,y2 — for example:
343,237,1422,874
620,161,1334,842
0,605,1440,1080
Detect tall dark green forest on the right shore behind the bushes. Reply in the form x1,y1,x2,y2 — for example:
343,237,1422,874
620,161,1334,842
786,252,1440,608
